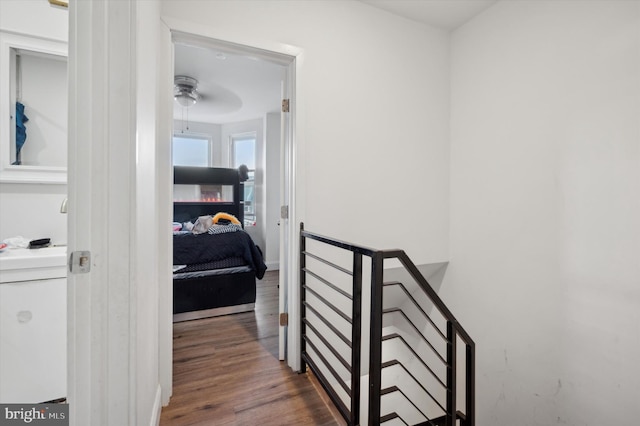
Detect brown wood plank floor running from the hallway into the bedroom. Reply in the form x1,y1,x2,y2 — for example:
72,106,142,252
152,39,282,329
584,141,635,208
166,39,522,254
160,271,342,426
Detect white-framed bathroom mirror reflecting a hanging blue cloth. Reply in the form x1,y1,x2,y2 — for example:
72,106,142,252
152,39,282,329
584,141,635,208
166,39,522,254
0,31,68,184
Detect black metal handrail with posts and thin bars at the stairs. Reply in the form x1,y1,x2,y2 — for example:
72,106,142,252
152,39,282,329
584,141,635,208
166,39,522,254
300,224,475,426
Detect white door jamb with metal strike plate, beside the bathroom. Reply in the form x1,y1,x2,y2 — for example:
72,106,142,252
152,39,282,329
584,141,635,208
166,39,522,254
67,1,136,425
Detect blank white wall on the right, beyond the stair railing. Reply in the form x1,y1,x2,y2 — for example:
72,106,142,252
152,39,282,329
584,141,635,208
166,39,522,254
441,1,640,426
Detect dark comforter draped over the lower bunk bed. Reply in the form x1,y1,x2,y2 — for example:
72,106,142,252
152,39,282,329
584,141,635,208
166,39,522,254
173,231,267,279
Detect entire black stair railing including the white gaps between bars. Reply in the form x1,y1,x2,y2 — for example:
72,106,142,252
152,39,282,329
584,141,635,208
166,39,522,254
300,224,475,426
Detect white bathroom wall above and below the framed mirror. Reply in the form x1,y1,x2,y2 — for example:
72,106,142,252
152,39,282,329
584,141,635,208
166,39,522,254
0,0,69,244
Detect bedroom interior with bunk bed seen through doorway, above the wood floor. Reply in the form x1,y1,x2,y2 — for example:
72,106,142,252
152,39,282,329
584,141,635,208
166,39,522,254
172,35,287,330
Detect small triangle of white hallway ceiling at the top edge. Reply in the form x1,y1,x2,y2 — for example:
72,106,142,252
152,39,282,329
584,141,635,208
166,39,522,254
360,0,498,30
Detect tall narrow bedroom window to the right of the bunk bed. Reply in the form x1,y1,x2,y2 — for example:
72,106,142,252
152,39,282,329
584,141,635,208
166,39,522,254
231,133,256,227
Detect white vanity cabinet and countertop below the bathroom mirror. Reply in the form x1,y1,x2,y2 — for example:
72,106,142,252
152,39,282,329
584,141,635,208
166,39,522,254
0,247,67,403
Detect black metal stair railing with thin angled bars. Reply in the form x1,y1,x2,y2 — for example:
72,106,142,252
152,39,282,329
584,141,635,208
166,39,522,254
300,224,475,426
